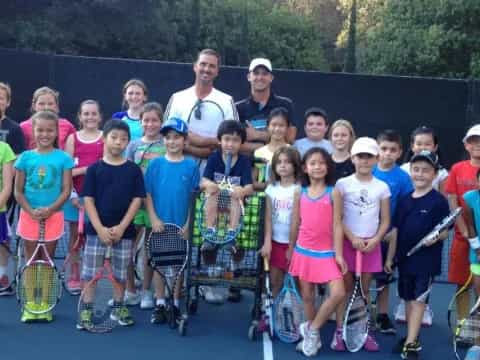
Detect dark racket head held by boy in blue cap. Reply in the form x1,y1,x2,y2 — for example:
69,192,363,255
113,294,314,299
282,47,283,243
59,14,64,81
147,223,189,278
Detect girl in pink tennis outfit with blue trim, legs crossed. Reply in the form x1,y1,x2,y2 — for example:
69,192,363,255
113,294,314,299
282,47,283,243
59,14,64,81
289,147,347,356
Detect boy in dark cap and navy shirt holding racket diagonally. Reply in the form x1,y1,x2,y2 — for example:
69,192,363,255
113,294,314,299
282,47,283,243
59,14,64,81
385,150,449,359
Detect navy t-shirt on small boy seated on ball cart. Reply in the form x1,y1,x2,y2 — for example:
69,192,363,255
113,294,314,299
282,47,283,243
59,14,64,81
203,150,252,186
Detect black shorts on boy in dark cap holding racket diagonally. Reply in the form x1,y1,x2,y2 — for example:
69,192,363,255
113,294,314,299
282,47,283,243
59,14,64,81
398,274,433,304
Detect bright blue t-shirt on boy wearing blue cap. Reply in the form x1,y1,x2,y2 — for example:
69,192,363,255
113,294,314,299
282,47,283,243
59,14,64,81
145,156,200,227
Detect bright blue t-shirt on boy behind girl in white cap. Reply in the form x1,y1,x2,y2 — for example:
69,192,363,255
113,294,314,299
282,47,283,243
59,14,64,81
373,165,413,219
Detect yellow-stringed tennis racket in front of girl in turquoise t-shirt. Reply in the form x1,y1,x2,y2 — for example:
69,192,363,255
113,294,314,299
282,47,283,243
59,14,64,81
17,220,62,314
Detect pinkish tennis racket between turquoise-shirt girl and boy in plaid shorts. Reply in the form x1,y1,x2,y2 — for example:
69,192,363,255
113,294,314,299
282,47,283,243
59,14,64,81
60,207,85,295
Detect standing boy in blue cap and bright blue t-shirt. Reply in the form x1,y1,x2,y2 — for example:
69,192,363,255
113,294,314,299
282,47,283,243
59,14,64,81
145,117,200,324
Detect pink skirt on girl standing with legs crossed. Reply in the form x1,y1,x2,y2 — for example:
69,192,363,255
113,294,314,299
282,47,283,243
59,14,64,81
289,248,342,284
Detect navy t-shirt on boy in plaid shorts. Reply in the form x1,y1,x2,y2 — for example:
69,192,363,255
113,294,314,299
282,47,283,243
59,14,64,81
82,160,145,238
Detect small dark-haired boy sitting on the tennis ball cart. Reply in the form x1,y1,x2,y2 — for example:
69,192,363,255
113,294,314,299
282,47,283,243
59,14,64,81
200,120,253,253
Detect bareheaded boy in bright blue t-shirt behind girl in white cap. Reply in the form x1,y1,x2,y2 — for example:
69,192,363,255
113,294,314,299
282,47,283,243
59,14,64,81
373,130,413,334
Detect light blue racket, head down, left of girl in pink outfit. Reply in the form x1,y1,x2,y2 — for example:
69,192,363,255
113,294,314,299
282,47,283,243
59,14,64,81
273,274,304,343
